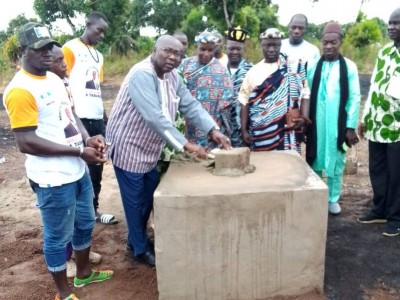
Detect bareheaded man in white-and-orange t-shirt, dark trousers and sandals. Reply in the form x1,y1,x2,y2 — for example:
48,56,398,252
62,11,118,224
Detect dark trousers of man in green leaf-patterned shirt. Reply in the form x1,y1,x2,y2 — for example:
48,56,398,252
368,142,400,226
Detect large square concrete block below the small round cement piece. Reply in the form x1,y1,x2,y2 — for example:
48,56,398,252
154,151,328,300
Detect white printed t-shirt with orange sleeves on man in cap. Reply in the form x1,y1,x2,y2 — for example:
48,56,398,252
3,70,85,186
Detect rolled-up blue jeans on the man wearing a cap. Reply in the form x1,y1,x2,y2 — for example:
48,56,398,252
31,173,95,272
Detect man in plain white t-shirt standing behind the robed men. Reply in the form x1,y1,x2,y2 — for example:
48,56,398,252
281,14,321,66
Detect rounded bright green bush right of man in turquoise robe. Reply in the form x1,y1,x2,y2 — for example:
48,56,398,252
345,20,382,47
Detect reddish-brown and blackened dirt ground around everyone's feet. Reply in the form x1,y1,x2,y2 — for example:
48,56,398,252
0,75,400,300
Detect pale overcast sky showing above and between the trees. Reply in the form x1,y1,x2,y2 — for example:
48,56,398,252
0,0,400,30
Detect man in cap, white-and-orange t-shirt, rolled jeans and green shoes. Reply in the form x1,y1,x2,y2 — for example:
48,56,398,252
3,22,113,300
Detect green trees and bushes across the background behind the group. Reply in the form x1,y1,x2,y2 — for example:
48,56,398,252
0,0,387,82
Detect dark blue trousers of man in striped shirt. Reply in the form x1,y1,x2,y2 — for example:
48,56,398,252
114,166,159,256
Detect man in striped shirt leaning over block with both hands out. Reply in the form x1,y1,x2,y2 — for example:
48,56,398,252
106,35,231,266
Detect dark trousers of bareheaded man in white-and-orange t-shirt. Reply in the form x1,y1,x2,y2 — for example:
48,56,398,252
81,119,105,211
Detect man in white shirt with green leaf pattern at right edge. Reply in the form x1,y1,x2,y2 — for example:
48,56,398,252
357,8,400,237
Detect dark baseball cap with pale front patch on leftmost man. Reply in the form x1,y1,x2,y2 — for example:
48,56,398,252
18,22,61,49
